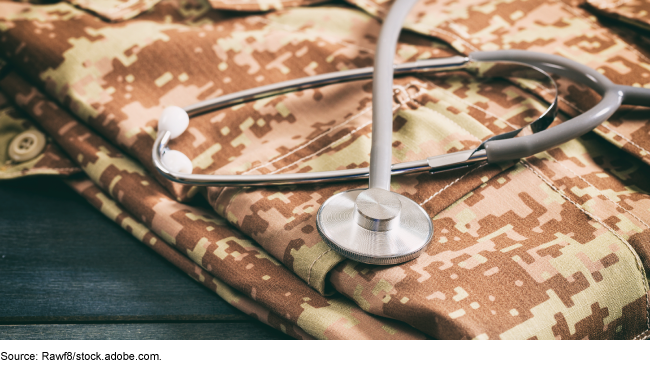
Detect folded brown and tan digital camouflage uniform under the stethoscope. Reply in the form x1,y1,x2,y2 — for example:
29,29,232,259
0,0,650,339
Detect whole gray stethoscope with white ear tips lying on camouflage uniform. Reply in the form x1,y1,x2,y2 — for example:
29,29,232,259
152,0,650,265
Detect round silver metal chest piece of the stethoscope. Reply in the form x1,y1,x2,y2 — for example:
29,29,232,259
316,188,433,265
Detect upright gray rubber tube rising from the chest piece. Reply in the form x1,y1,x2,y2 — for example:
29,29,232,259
368,0,418,191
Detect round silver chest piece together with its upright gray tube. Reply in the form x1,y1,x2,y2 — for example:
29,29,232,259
316,0,433,265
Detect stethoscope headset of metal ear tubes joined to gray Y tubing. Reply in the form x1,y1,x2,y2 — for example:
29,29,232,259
152,50,650,186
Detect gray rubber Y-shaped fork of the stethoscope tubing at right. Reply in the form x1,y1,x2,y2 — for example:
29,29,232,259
469,50,624,162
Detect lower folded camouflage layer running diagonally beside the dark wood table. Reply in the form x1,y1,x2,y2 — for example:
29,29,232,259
0,74,424,339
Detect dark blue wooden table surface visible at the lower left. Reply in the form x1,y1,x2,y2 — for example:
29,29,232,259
0,177,289,339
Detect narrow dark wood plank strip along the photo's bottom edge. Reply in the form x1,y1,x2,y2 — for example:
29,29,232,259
0,322,290,340
